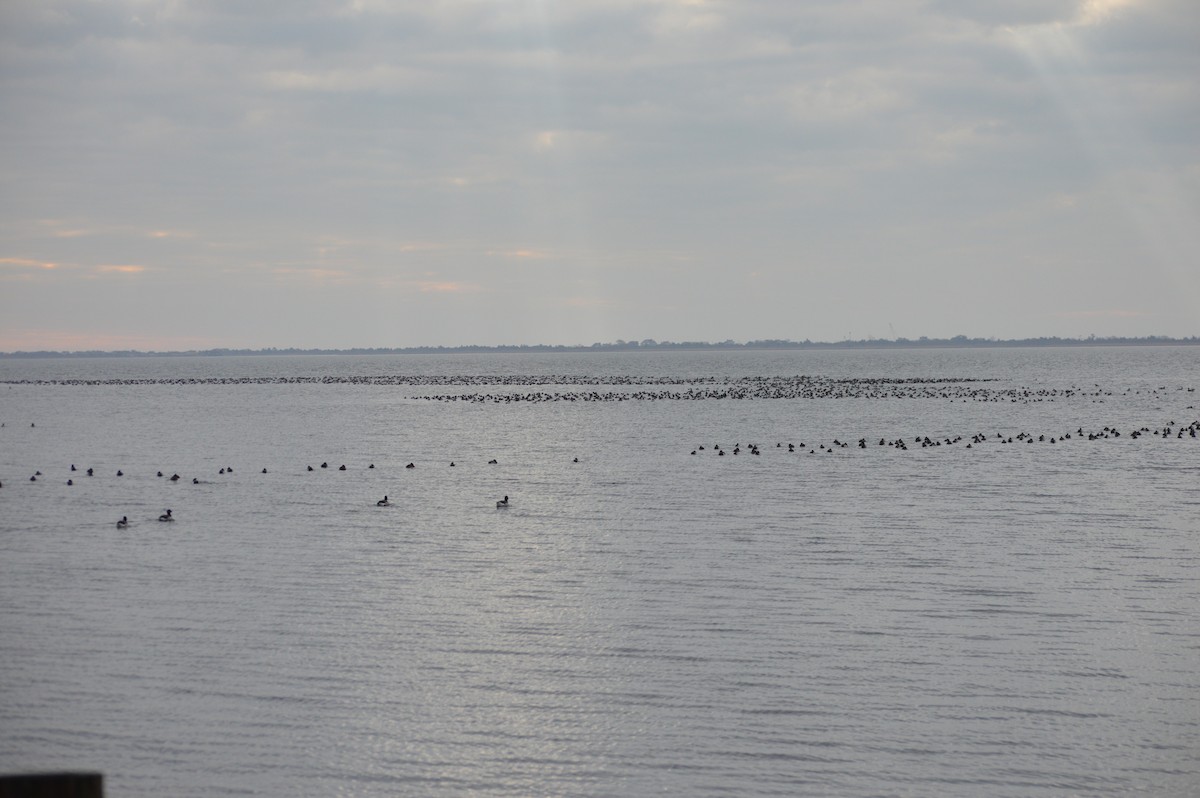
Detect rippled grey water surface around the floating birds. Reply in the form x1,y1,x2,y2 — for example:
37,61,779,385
0,347,1200,797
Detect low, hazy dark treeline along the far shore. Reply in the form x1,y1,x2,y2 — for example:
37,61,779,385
0,335,1200,358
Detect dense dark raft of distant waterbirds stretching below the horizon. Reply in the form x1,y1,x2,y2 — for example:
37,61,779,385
7,374,1195,403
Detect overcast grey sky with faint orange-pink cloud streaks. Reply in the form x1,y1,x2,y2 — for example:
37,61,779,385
0,0,1200,352
